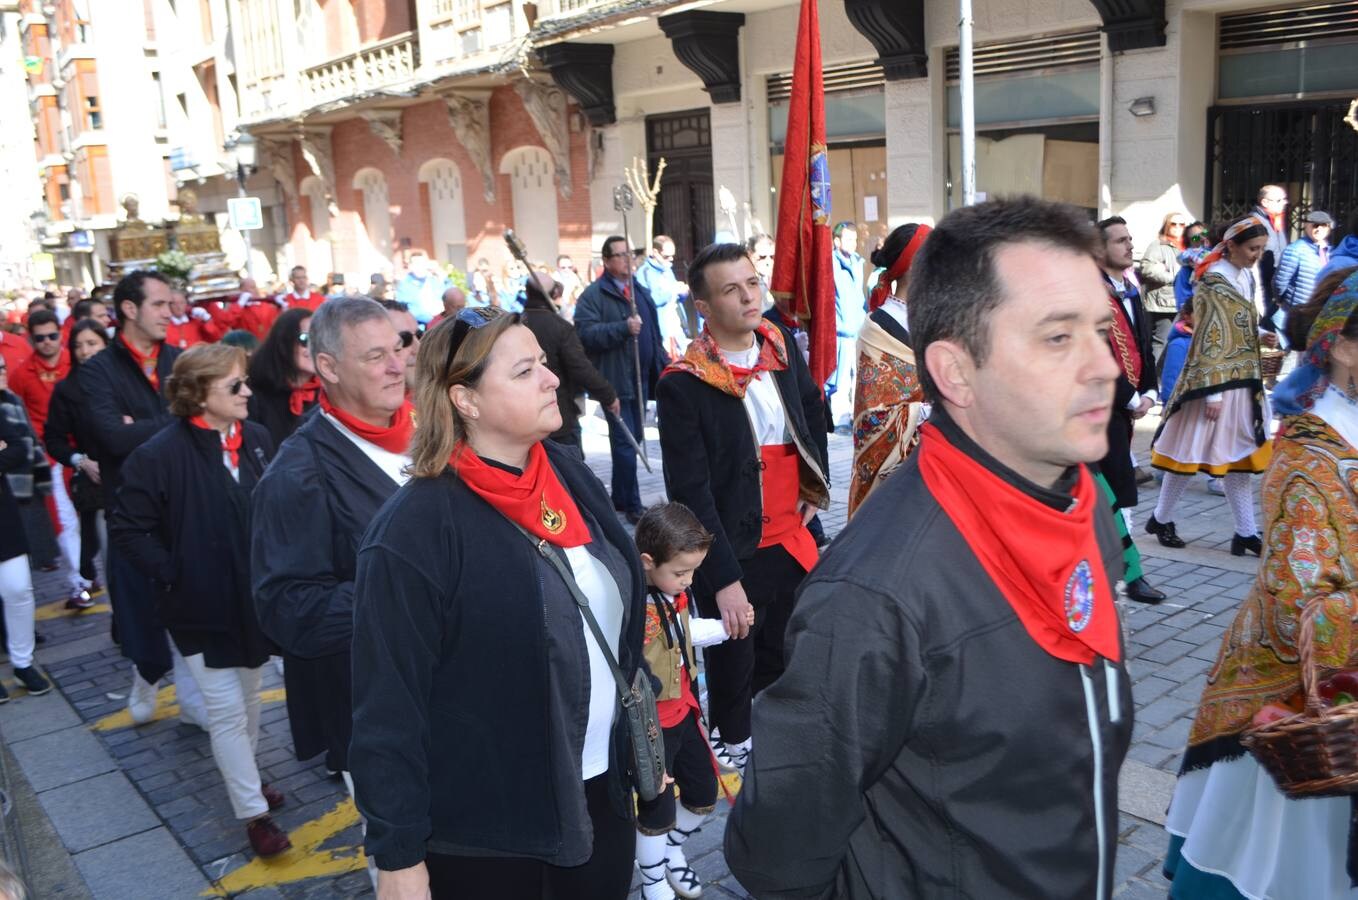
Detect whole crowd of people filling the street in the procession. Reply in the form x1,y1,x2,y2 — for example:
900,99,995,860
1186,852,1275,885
0,185,1358,900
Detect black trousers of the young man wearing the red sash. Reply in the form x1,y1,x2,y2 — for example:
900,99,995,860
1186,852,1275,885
698,546,807,744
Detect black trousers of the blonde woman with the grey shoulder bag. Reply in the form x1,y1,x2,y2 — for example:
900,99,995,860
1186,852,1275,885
425,772,637,900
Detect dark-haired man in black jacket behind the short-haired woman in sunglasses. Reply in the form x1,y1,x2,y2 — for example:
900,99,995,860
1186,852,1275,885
77,271,208,728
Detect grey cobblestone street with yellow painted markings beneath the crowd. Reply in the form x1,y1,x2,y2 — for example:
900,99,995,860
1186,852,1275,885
0,412,1255,900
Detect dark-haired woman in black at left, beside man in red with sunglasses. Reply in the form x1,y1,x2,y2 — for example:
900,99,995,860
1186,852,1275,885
42,319,109,610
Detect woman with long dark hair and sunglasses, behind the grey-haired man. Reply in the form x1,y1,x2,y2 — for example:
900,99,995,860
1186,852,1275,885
250,307,320,447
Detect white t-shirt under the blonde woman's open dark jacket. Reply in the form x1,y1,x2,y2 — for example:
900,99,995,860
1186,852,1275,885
565,546,622,781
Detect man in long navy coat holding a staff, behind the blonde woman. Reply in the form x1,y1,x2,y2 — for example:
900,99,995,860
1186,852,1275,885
576,235,669,524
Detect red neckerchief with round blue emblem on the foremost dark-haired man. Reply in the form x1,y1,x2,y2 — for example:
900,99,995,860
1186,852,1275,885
915,424,1122,665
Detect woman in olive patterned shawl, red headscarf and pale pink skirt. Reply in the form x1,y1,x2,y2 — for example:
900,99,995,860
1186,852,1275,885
1146,216,1271,557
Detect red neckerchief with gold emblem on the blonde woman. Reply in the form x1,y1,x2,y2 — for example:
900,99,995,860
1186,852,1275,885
448,443,591,547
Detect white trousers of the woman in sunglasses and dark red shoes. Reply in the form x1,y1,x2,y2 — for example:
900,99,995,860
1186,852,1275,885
177,653,269,820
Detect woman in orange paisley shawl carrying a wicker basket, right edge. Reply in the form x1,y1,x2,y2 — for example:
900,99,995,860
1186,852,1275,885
1165,269,1358,900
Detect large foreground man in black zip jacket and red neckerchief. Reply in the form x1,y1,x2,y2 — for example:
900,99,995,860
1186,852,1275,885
725,198,1133,900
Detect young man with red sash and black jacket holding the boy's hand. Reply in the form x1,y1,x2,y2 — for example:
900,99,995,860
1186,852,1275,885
656,244,830,770
